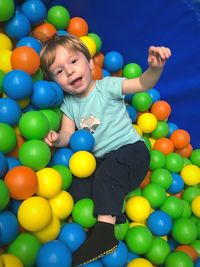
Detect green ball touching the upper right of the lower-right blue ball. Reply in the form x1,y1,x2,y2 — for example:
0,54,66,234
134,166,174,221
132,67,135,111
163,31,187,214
160,196,183,220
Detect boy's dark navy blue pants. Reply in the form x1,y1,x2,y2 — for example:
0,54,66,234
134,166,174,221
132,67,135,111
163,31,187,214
69,141,150,223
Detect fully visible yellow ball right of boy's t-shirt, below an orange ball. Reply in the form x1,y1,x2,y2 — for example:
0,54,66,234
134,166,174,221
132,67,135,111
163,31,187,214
137,113,157,133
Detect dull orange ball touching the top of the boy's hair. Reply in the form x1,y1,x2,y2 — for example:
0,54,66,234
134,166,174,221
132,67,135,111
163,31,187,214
33,22,57,42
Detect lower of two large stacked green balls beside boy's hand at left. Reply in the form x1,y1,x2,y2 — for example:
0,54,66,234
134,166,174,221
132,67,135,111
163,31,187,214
19,139,51,171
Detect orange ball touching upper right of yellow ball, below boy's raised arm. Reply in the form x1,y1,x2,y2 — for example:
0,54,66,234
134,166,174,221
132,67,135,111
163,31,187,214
151,100,171,121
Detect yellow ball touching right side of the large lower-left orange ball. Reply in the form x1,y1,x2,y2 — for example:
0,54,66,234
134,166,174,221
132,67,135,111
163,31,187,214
36,167,62,199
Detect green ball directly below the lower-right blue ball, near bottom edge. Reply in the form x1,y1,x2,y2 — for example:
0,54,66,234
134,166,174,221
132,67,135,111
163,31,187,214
145,237,170,265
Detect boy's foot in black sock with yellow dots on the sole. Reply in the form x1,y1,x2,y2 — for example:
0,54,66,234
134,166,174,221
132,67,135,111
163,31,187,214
72,221,119,266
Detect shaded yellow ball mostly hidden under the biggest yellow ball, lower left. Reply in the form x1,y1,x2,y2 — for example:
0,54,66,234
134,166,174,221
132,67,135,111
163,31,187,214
34,215,61,243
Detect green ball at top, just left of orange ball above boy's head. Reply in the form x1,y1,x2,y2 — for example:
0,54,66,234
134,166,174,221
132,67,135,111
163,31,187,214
47,5,70,30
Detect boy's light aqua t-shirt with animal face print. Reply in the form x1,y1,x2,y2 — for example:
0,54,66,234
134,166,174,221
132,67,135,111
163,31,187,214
61,77,141,157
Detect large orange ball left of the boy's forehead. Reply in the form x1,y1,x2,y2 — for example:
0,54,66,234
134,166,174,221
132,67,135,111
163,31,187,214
10,46,40,75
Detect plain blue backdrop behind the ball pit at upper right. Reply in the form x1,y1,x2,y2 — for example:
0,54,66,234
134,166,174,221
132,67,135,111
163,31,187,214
47,0,200,148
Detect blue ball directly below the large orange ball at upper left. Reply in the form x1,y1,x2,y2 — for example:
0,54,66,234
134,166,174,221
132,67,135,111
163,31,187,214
3,70,33,100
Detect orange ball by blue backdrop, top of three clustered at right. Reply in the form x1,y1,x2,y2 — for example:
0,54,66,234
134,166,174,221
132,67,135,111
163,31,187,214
170,129,190,149
